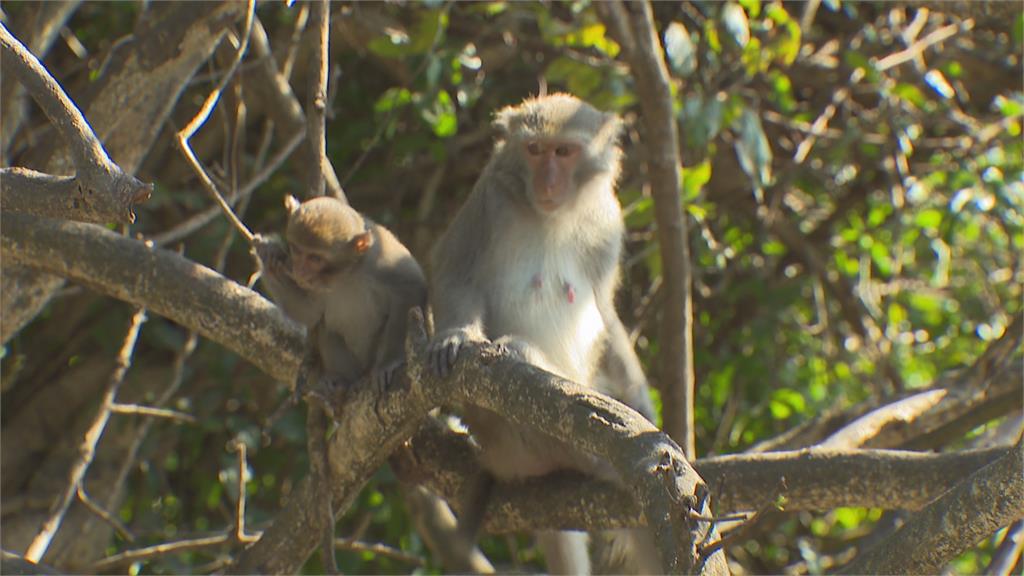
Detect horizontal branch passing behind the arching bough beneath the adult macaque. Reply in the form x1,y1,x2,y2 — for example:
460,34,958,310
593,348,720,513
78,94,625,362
399,420,1007,522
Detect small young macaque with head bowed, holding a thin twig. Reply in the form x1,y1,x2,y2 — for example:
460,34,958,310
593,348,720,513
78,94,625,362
256,196,427,387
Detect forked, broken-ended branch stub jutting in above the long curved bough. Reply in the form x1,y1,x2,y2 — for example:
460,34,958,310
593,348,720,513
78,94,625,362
0,24,153,222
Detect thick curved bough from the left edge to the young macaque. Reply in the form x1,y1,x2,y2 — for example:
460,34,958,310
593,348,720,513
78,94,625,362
0,212,302,382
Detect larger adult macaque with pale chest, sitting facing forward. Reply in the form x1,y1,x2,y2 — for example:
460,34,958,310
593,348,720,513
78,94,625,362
429,94,662,573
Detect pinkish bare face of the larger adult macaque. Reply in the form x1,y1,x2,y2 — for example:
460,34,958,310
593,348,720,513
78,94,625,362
523,140,583,213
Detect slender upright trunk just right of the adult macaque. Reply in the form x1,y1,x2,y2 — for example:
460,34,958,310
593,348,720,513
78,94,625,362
596,1,696,459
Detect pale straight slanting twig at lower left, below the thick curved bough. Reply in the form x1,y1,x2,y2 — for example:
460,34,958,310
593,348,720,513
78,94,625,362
25,307,145,562
